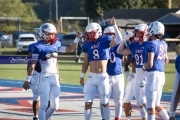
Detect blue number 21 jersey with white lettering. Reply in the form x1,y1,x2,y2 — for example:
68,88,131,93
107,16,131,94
129,41,149,68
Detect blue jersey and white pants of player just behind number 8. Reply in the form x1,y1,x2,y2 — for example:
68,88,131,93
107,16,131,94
107,45,124,118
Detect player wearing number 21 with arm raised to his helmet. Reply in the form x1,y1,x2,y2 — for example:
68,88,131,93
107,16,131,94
118,24,148,120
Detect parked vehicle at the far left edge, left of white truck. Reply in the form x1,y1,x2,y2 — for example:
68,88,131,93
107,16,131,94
0,34,13,47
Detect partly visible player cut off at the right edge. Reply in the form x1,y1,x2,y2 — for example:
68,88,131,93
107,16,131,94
169,55,180,120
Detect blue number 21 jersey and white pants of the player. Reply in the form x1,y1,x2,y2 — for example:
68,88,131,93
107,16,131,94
129,41,149,106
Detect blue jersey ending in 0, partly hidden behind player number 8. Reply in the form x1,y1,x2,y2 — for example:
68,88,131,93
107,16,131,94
107,45,123,76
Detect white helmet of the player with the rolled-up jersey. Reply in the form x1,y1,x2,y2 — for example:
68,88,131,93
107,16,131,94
40,23,57,43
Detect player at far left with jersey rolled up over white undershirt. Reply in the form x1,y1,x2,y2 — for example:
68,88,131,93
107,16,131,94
23,23,81,120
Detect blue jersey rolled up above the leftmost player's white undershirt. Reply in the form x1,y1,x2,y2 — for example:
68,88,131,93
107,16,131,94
32,40,61,61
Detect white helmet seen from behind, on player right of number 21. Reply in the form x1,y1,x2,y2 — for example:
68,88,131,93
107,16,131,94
148,21,164,37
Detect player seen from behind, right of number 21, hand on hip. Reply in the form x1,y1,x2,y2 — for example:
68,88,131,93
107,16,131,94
142,21,169,120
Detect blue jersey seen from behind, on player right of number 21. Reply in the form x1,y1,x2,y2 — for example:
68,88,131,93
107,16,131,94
147,40,168,72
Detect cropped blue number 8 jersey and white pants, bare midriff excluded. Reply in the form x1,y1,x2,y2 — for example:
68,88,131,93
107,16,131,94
82,35,112,104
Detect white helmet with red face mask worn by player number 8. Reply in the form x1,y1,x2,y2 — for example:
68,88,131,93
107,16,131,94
85,23,102,42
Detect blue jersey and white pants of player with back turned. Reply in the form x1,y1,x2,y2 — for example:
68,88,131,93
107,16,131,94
146,40,167,109
